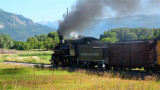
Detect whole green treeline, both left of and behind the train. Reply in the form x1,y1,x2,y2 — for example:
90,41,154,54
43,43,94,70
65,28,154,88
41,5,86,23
0,28,160,50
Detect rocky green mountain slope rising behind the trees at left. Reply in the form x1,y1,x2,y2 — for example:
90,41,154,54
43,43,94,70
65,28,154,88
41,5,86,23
0,10,55,41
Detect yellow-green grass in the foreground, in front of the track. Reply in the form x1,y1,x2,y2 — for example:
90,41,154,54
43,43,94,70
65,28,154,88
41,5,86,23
0,64,160,90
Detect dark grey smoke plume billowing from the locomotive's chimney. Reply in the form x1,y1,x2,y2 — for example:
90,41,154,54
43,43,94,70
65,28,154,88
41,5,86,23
58,0,160,36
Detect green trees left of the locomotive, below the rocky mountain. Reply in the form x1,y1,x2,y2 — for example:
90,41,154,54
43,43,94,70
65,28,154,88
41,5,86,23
0,32,59,50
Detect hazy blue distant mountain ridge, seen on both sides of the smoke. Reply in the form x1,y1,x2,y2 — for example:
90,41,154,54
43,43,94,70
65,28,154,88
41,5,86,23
39,14,160,38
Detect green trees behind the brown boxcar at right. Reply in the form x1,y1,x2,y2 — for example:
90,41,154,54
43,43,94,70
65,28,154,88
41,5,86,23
100,28,160,43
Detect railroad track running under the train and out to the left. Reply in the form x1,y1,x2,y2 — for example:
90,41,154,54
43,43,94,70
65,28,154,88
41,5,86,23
3,61,160,80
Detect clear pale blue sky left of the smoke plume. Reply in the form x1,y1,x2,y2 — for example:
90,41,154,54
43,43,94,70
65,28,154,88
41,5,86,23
0,0,76,22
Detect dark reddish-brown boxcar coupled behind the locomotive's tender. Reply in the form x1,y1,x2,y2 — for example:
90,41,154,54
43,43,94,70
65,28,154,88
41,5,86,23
108,40,160,72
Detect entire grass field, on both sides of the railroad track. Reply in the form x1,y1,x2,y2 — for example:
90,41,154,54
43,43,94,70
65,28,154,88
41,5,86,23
0,51,160,90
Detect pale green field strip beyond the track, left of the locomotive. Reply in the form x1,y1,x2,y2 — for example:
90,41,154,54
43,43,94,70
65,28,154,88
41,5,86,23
0,51,53,64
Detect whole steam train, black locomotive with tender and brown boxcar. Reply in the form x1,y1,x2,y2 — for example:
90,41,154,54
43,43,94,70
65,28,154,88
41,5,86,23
50,36,160,72
